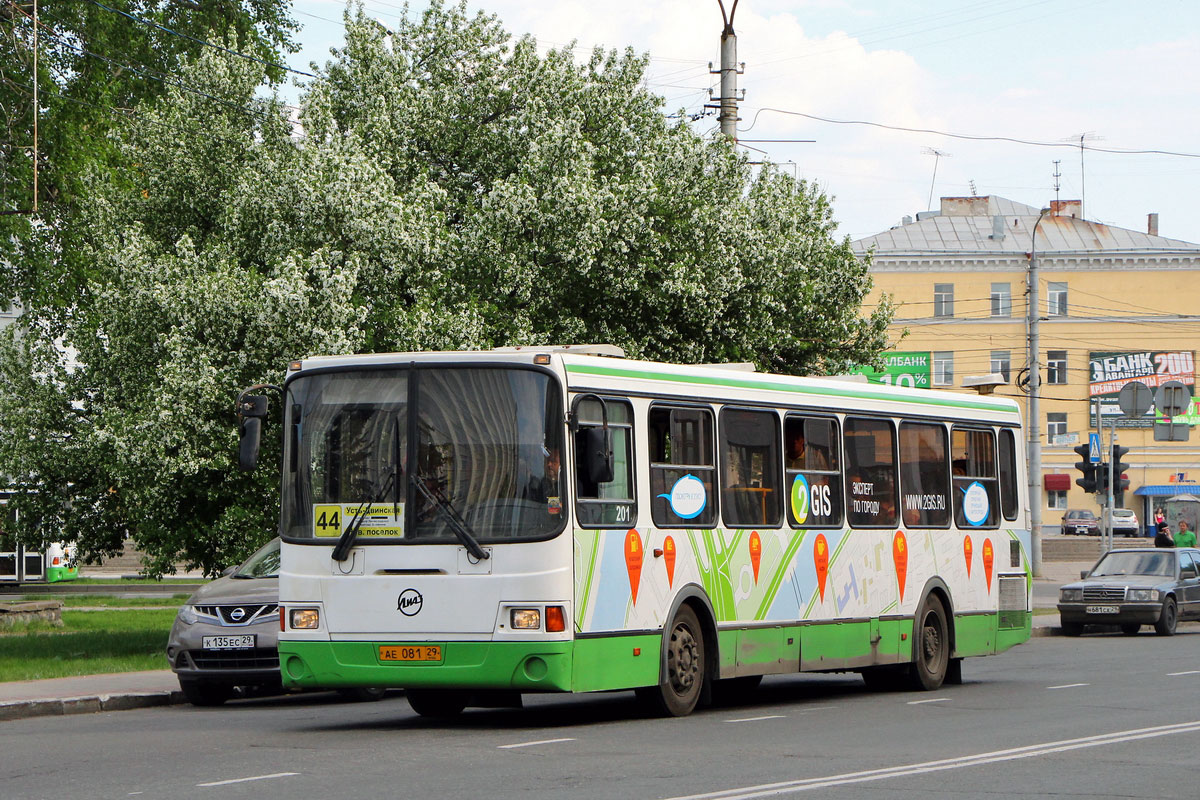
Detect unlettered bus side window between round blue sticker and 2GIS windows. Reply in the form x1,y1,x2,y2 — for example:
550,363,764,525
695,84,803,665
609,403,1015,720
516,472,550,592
720,408,780,528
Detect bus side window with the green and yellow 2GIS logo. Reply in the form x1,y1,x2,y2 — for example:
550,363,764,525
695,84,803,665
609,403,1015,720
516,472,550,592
784,414,842,528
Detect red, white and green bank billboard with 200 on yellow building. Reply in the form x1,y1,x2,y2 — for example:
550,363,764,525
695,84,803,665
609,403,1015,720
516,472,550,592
1087,350,1196,428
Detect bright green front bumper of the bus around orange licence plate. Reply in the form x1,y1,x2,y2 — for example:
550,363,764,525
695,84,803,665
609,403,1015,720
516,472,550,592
280,642,571,692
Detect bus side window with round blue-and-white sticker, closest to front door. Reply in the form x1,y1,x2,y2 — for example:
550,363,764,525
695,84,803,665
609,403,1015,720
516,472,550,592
647,405,716,528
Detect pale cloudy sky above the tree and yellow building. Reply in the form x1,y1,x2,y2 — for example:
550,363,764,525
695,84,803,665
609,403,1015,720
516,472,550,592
278,0,1200,243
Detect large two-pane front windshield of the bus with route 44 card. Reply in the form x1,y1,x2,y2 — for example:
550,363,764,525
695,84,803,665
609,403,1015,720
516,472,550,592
281,367,566,543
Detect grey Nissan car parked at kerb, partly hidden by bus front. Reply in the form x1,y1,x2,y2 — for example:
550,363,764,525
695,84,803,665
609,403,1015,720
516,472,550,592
167,539,384,705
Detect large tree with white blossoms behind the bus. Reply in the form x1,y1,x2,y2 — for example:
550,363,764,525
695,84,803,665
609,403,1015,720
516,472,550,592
0,2,890,575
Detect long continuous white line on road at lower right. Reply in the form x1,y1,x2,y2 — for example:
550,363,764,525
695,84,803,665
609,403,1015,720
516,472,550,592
667,720,1200,800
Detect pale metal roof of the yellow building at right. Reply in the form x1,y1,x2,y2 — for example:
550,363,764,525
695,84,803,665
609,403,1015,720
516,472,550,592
851,196,1200,257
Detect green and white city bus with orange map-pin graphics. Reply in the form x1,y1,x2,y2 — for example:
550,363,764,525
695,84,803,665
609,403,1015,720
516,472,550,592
238,345,1031,715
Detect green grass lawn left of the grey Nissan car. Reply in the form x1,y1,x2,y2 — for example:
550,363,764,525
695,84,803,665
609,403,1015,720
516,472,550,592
0,603,178,681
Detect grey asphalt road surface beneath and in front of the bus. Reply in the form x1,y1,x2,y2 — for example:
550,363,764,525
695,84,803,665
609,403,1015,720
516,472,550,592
0,625,1200,800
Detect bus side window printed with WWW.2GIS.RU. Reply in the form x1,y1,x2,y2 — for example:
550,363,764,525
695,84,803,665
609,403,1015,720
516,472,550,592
900,422,950,528
